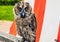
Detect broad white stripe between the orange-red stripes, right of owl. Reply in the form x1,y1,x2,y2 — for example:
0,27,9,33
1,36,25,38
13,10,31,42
40,0,60,42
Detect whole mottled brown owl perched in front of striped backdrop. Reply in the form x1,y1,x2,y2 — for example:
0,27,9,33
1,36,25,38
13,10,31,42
14,2,37,42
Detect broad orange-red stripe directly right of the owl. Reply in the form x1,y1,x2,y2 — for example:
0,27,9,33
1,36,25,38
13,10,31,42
34,0,46,42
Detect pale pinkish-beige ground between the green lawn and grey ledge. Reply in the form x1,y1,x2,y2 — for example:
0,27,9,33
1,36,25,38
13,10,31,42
0,20,12,32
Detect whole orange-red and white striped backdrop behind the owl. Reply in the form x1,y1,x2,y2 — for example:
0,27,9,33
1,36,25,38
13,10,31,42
10,0,60,42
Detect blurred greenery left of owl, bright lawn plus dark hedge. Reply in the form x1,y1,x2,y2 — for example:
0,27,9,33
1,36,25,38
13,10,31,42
0,0,20,21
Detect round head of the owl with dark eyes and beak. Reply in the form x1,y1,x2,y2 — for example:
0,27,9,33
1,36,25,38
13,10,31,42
14,2,32,18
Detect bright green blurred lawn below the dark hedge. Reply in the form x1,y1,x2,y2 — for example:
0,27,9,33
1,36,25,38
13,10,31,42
0,6,14,21
